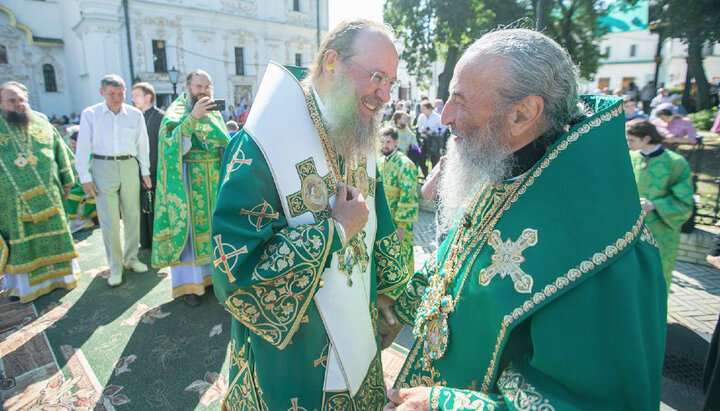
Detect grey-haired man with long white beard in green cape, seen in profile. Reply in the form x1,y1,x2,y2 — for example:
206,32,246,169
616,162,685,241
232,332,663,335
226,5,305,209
385,29,666,410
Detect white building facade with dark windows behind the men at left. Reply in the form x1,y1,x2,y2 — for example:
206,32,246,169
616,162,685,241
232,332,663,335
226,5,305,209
0,0,328,116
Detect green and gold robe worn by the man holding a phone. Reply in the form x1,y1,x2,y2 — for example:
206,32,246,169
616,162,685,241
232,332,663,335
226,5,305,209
152,93,229,267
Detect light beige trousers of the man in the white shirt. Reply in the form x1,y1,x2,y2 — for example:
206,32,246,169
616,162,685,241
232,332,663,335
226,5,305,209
90,158,140,273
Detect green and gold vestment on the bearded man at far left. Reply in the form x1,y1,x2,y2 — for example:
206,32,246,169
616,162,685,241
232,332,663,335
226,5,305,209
0,115,77,292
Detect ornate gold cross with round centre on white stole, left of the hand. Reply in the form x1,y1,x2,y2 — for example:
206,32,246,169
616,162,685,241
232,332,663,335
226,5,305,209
287,157,335,221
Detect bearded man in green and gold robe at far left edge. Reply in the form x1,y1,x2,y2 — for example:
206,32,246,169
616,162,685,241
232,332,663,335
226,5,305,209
0,81,80,302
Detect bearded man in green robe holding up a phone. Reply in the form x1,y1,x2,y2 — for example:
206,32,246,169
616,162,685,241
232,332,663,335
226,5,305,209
152,70,229,306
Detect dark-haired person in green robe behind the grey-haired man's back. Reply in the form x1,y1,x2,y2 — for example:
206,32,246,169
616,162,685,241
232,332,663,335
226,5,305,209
625,119,693,292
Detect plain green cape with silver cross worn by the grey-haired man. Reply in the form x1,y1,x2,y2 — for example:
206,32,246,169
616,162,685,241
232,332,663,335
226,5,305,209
395,96,667,410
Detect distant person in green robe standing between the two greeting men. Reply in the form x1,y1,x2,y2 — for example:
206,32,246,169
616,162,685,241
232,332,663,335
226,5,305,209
377,127,418,273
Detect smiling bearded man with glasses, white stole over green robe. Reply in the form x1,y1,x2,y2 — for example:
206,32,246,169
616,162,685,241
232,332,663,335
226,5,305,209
212,20,409,410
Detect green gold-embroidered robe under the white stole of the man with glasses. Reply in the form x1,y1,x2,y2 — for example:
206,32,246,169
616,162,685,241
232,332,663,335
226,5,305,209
213,129,408,410
